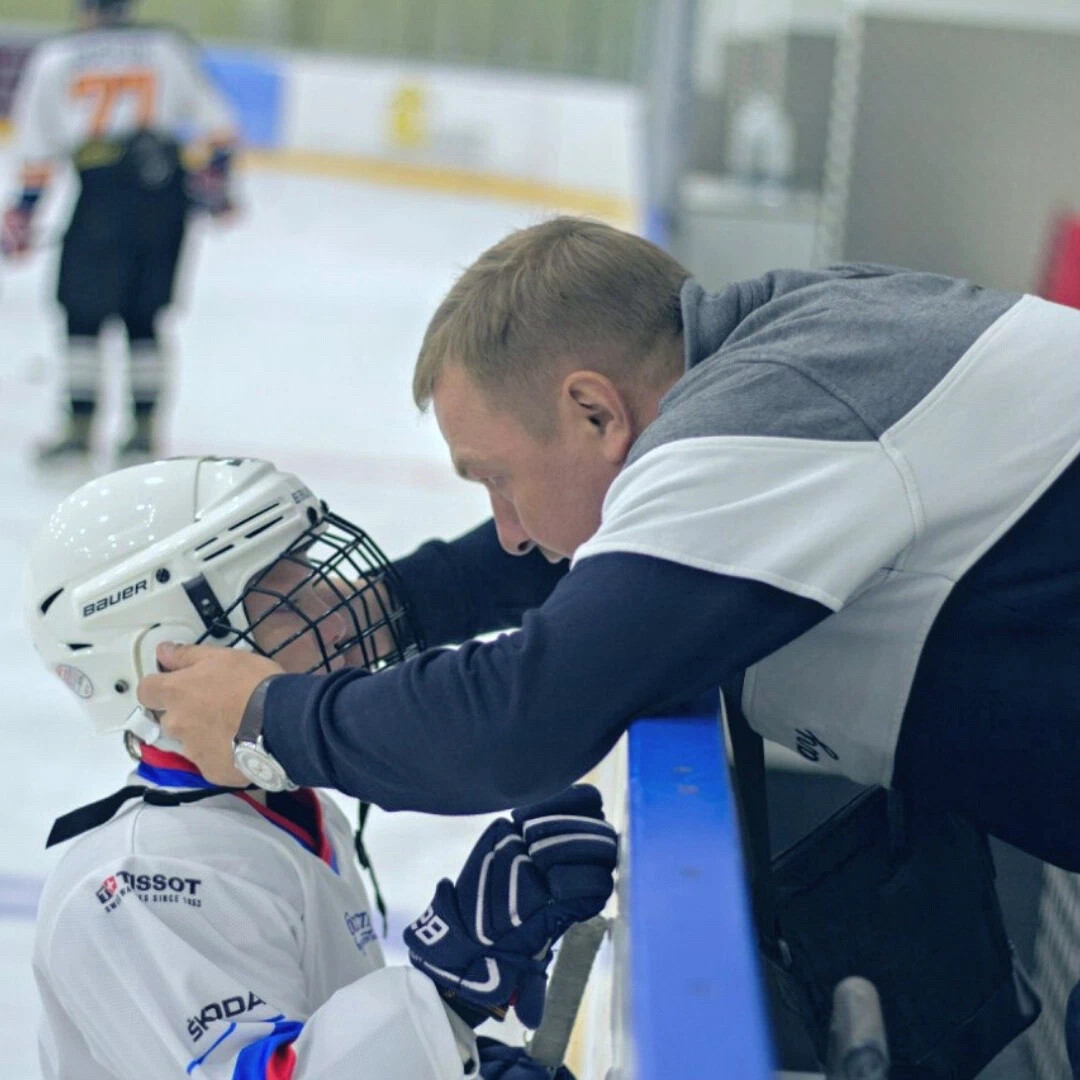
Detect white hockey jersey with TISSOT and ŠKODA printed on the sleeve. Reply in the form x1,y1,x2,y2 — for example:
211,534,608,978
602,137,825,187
33,747,477,1080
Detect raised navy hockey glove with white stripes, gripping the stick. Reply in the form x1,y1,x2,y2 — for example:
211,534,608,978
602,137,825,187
404,785,617,1027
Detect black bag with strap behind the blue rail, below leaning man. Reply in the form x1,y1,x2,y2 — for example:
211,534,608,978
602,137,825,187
728,710,1041,1080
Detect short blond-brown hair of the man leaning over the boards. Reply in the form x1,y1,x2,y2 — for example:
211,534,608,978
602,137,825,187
413,217,689,432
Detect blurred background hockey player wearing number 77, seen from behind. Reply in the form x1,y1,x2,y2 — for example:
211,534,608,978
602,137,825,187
0,0,235,462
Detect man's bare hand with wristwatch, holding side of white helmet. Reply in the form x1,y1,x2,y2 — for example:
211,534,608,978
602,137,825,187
137,644,284,787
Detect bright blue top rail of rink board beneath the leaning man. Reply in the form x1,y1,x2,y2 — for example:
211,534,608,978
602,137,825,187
629,716,773,1080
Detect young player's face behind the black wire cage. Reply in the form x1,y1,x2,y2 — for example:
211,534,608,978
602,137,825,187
244,557,354,673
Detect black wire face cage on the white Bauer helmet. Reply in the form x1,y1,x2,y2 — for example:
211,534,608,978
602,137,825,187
196,504,422,674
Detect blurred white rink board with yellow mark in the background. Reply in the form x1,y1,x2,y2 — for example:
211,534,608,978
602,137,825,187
281,53,644,200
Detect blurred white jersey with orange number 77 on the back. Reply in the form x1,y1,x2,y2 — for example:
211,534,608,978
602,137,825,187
12,24,235,179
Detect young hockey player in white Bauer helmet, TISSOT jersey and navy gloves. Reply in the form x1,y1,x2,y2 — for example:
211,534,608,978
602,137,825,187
25,458,616,1080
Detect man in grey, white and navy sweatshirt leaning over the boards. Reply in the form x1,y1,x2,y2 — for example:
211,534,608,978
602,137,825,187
139,218,1080,870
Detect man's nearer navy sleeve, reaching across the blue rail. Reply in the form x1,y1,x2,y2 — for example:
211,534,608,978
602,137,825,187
264,555,828,813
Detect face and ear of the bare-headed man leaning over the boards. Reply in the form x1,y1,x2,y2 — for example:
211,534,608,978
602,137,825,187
432,364,621,563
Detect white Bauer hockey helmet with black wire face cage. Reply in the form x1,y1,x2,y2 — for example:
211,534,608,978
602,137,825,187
24,457,419,733
